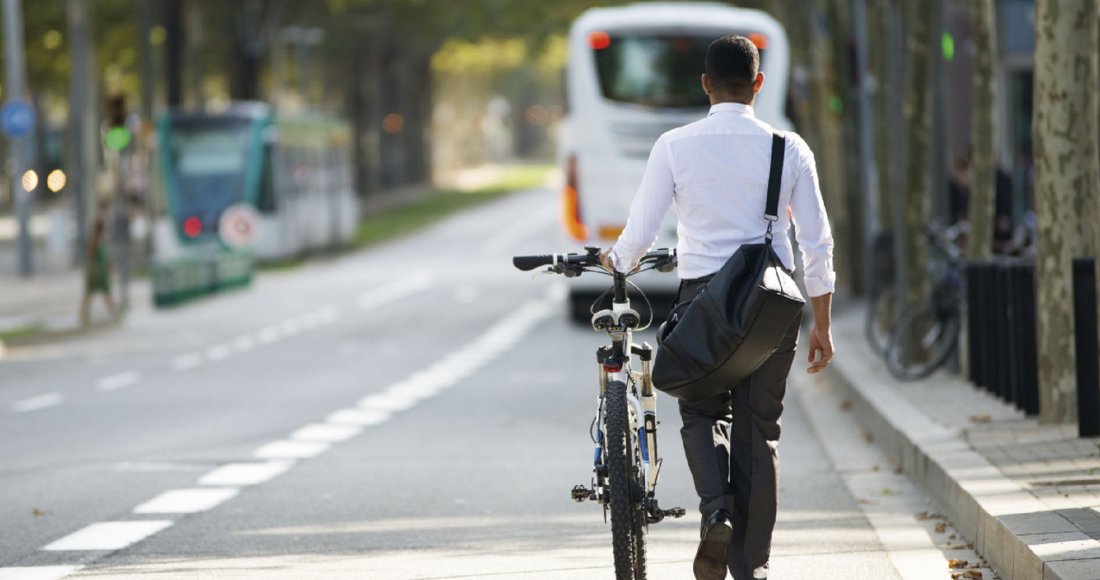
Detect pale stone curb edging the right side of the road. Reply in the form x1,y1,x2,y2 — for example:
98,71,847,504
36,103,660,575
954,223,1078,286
827,309,1100,580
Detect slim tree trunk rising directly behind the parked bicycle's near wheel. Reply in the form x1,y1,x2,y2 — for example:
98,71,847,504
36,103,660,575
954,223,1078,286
901,0,932,312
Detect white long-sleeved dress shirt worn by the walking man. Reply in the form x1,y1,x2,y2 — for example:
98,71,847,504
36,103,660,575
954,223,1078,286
611,102,836,296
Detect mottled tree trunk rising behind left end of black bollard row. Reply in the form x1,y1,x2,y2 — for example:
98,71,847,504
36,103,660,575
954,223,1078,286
967,0,997,261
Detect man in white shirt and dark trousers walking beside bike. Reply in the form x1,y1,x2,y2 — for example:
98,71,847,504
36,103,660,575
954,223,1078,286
601,35,835,580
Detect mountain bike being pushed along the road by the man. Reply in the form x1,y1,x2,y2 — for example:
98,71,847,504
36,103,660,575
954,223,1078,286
513,248,685,580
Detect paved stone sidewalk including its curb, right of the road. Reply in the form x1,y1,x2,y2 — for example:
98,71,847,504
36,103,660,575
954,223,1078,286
831,303,1100,580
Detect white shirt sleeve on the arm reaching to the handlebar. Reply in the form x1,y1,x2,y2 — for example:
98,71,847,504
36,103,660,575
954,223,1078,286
611,135,675,272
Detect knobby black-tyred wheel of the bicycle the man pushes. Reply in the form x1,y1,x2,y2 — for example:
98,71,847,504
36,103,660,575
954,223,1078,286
604,381,647,580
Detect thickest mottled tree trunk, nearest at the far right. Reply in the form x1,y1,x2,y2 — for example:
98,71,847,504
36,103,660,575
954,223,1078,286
1033,0,1100,423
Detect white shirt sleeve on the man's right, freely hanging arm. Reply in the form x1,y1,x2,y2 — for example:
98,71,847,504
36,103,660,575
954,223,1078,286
791,140,836,297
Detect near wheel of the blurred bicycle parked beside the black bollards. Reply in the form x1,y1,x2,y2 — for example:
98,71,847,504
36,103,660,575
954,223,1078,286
887,304,961,381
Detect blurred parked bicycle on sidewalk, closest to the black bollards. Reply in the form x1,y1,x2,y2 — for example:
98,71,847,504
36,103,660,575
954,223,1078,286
886,225,965,381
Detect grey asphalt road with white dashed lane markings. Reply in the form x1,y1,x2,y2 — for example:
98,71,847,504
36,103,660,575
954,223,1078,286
0,190,994,580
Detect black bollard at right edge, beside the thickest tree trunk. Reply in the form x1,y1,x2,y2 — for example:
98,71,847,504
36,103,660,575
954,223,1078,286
1074,258,1100,437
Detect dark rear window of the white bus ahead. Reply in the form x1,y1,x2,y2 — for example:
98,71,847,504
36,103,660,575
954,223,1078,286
593,32,762,108
